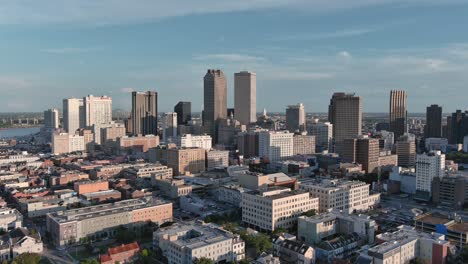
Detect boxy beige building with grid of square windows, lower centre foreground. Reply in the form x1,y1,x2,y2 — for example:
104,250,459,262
242,187,319,231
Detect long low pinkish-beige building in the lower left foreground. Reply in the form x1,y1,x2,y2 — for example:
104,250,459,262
46,197,172,247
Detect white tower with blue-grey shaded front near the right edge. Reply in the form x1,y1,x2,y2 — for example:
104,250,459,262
416,151,445,194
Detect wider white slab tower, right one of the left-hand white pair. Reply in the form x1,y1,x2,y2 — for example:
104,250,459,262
83,95,112,127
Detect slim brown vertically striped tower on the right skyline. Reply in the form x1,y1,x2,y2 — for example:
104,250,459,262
389,90,407,138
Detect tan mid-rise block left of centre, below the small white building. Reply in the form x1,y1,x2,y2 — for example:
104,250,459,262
165,148,206,176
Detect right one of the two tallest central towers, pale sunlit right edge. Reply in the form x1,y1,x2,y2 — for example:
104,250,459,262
234,71,257,125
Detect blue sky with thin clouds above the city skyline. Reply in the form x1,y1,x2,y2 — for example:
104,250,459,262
0,0,468,112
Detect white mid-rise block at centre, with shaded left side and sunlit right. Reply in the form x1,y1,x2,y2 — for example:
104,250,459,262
258,131,294,162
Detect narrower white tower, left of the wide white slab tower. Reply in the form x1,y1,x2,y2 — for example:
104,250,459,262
63,98,85,134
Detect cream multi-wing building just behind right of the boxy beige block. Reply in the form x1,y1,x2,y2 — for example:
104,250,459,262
299,179,380,213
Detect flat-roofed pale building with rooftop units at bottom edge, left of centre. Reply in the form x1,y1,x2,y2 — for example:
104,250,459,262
153,223,245,264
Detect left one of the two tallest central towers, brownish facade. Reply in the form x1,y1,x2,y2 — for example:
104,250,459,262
203,69,227,142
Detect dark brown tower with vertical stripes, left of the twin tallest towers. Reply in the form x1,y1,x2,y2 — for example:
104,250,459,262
130,91,158,135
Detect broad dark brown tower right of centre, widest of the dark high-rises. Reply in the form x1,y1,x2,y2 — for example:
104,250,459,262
328,93,362,152
